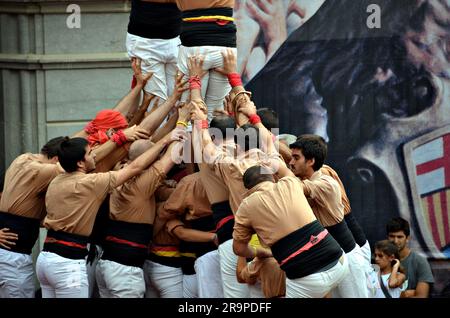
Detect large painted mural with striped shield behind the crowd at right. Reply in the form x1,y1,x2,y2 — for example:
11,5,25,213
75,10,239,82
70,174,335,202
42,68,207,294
235,0,450,293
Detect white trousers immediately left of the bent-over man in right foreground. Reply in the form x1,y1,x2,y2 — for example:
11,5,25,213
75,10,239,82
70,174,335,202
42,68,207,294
218,239,250,298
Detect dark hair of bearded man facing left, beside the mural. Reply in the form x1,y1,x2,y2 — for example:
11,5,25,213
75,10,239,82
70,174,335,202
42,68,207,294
289,135,327,171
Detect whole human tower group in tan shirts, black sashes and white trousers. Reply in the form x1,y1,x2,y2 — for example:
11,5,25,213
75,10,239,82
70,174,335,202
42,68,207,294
0,1,371,298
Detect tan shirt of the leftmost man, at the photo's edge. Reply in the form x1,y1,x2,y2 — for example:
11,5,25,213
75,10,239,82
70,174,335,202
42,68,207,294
0,153,63,220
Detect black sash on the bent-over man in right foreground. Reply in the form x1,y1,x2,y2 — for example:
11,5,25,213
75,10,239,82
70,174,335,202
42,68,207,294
271,220,342,279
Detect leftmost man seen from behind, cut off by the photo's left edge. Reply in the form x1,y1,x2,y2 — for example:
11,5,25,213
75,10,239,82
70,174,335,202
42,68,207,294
0,137,63,298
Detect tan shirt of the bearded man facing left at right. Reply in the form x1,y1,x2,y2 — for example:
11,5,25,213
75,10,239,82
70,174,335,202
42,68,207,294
301,170,344,226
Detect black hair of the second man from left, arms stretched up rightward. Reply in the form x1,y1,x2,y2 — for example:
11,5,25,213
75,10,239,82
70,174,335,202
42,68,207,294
58,137,88,173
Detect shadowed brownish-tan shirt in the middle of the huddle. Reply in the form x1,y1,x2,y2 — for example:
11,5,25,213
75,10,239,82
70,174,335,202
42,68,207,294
164,172,212,221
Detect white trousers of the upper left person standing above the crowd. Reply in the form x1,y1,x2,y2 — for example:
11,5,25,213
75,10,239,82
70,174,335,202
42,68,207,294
126,33,181,101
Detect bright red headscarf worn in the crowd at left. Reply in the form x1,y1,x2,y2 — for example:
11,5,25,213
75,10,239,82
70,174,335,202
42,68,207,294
84,109,128,146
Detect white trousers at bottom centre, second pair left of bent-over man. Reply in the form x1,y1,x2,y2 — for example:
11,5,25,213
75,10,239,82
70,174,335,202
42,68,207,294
194,250,223,298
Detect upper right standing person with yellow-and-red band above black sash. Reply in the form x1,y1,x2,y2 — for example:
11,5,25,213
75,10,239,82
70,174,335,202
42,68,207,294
177,0,237,120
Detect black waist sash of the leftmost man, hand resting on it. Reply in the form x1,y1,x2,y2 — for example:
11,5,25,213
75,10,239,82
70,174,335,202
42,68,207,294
0,212,40,255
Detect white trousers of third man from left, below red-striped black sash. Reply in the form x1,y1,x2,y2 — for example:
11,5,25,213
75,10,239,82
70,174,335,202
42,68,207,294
95,259,145,298
